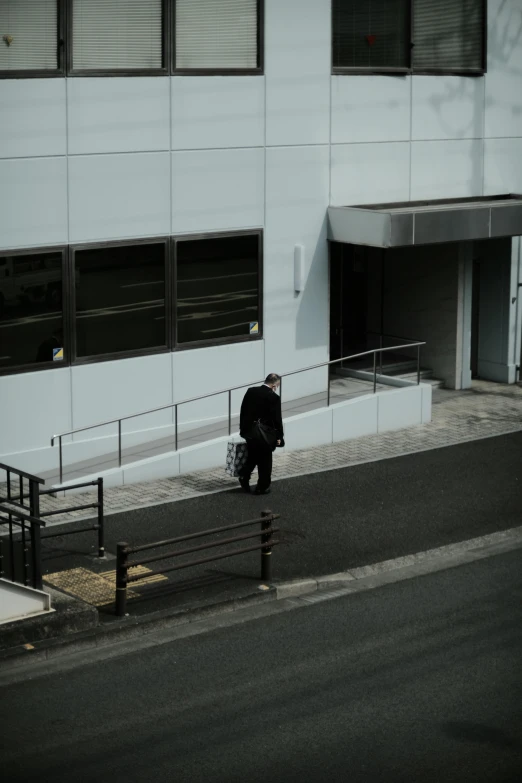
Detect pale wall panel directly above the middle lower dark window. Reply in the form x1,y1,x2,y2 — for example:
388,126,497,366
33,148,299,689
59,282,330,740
69,152,170,242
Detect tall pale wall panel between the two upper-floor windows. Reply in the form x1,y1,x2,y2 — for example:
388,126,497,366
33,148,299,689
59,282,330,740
265,0,331,145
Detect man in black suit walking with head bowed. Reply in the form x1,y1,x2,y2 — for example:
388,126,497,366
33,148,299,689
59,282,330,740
239,373,285,495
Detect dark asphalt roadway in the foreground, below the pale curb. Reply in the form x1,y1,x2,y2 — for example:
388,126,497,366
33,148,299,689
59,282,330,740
0,550,522,783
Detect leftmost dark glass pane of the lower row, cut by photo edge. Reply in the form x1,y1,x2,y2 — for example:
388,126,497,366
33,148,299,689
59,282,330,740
0,250,66,370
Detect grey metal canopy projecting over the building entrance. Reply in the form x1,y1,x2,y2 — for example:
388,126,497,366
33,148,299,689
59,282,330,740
328,194,522,248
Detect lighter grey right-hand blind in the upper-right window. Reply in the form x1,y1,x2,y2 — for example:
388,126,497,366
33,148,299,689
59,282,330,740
413,0,483,71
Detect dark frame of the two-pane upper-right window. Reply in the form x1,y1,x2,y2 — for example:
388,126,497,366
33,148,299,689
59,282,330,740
330,0,488,77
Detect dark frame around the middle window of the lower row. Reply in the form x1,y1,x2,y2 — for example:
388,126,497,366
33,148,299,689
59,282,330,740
68,237,173,366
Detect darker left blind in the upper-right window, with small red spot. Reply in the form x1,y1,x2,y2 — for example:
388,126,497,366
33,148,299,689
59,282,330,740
333,0,410,68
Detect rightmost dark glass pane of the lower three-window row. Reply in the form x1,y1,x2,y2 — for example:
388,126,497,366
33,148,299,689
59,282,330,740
176,233,261,344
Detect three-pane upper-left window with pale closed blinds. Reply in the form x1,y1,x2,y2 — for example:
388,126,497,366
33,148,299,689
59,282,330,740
0,0,264,79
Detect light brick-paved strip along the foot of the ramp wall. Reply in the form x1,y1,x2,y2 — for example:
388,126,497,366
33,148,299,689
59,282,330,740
5,381,522,526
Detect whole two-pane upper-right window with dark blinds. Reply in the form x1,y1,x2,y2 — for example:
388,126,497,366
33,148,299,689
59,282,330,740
332,0,486,75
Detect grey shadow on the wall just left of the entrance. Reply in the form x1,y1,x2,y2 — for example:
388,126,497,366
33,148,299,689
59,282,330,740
294,209,329,351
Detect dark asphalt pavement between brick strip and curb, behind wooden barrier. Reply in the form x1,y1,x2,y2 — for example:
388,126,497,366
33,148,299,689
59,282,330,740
44,432,522,579
